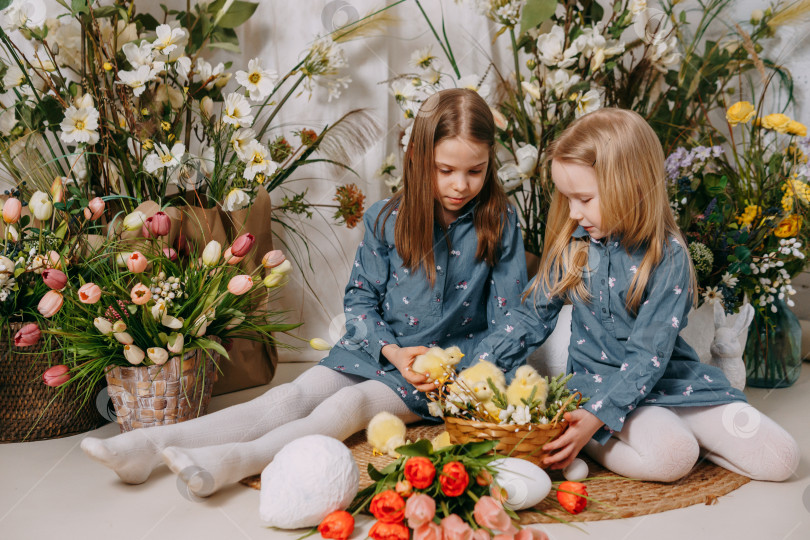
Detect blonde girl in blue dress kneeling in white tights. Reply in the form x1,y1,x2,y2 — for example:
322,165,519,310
476,109,799,481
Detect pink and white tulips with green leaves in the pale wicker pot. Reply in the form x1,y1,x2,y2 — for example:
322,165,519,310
26,212,297,397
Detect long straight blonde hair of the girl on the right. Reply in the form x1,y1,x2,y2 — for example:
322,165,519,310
524,108,697,313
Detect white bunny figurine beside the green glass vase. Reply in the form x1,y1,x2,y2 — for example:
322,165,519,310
706,302,754,391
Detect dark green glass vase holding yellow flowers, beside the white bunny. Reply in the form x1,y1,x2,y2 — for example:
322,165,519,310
743,300,802,388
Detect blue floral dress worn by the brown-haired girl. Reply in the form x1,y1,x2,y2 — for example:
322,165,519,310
321,199,527,421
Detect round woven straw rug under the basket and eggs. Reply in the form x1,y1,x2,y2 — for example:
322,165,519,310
242,424,750,525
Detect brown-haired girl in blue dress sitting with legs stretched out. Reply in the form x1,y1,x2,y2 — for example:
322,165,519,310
82,89,526,496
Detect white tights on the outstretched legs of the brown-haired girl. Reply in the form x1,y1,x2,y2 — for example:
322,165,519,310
81,366,419,497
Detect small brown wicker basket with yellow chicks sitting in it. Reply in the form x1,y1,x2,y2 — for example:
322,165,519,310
444,416,568,467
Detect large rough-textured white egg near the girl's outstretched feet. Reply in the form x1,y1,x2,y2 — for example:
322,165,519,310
259,435,360,529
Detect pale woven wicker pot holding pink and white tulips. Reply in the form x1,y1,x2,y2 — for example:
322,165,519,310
106,350,214,433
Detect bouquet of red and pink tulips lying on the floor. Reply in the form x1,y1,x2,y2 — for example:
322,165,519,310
330,439,550,540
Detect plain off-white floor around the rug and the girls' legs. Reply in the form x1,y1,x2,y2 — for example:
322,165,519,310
0,364,810,540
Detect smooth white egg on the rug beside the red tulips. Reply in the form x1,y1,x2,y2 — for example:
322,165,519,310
490,458,551,510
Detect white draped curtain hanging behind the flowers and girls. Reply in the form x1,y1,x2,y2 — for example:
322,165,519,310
22,0,810,361
